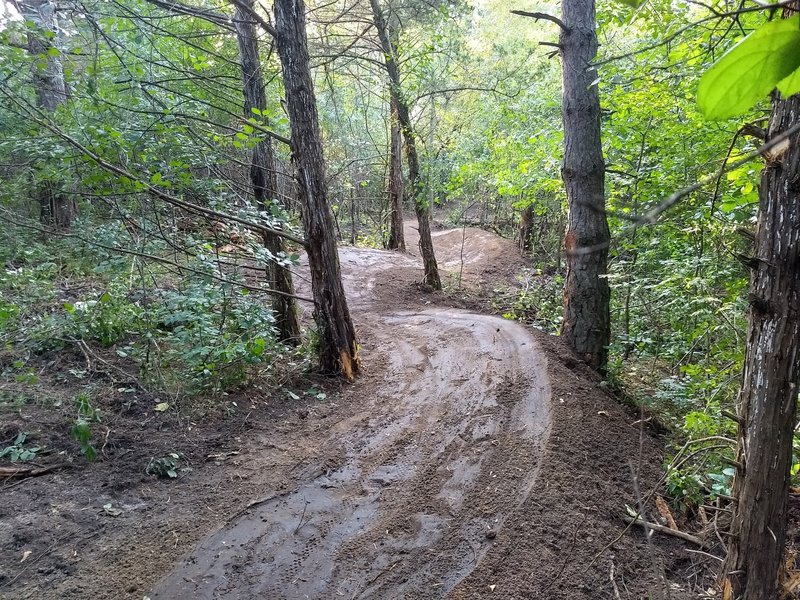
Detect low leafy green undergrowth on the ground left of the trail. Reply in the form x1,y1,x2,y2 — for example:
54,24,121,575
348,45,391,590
0,224,303,407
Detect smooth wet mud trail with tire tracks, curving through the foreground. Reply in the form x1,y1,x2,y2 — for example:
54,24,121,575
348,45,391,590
151,249,550,600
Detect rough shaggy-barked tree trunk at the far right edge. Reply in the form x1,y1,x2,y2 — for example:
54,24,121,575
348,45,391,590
724,89,800,600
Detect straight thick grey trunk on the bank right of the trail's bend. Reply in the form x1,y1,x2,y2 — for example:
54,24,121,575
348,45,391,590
559,0,611,372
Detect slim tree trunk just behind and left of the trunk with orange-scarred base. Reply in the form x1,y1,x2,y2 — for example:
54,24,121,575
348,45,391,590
235,0,300,345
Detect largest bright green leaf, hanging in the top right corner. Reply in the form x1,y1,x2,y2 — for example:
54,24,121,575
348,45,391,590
697,14,800,119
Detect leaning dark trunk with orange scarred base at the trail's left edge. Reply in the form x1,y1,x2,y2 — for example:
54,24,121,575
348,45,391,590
275,0,358,380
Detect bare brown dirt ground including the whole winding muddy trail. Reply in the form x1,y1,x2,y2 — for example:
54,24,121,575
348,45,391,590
0,227,706,600
